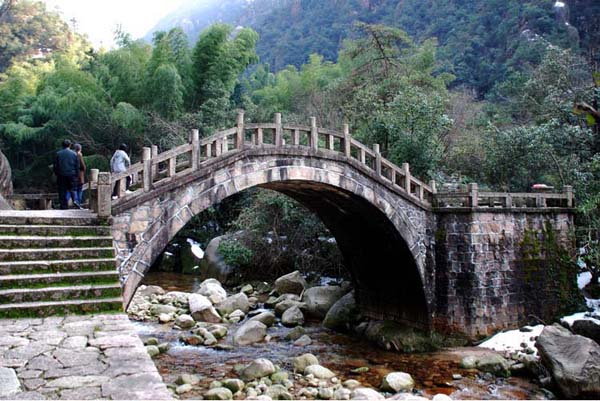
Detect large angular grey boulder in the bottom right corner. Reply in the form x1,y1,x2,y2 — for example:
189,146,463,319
535,324,600,399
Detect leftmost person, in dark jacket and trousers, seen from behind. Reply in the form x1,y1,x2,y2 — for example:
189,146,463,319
54,139,81,209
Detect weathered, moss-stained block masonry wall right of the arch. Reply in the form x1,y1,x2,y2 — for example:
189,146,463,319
435,212,575,336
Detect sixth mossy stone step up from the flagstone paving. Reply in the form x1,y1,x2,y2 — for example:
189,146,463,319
0,235,112,249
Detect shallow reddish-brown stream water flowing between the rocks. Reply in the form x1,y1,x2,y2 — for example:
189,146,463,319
135,273,544,399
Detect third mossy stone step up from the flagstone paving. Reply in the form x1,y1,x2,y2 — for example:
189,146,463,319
0,271,119,290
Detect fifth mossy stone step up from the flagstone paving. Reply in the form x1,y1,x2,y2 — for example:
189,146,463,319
0,247,114,262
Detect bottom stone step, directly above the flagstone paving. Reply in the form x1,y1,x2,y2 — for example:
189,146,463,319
0,297,123,318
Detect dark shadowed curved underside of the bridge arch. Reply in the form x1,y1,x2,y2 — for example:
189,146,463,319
261,181,428,326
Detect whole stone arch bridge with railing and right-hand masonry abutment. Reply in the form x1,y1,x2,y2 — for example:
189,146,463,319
91,113,574,336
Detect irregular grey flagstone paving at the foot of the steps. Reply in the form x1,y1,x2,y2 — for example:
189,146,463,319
0,314,172,400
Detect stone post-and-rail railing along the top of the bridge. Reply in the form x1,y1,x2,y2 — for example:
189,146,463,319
90,112,572,217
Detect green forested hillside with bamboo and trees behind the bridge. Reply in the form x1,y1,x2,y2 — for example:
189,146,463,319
0,0,600,282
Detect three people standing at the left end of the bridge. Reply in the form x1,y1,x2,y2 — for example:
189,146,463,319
54,139,131,209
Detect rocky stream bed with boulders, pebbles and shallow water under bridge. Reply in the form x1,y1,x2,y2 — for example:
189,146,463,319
129,272,580,399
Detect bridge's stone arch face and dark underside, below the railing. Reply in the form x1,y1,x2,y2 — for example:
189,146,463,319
113,150,431,327
